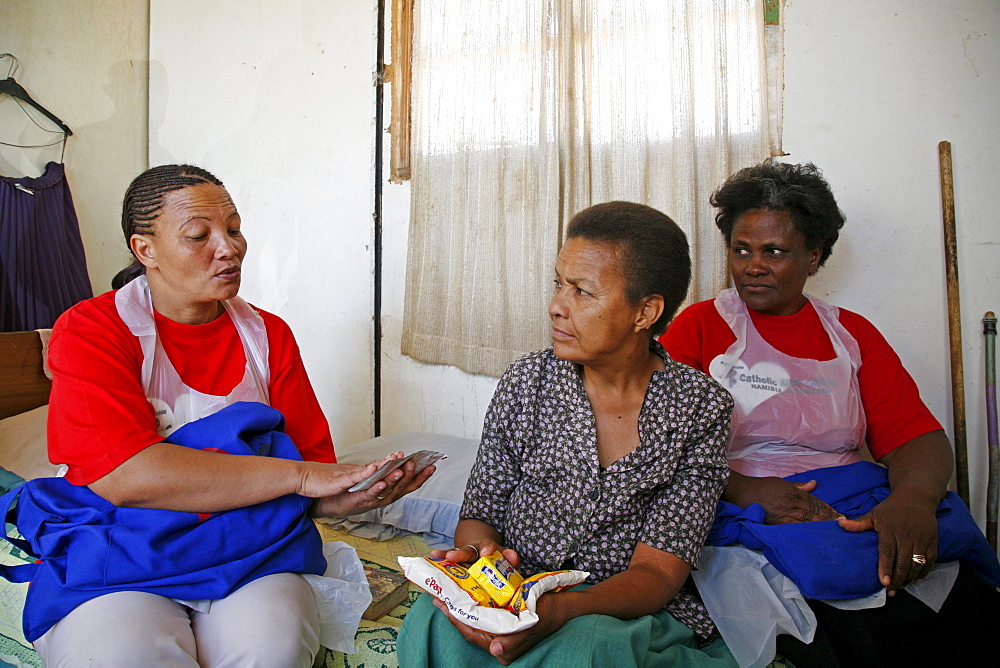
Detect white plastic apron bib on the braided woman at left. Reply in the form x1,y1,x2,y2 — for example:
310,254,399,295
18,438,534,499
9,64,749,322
115,276,270,436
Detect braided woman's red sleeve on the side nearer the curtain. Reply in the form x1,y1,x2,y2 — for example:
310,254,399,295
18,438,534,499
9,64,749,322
257,309,337,463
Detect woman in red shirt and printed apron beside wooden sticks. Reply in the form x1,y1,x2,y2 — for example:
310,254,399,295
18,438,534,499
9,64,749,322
661,161,1000,666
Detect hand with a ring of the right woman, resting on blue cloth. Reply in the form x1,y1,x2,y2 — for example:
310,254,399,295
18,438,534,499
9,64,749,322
840,495,937,596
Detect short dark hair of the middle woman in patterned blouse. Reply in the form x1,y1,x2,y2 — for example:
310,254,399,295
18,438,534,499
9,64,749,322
566,197,691,337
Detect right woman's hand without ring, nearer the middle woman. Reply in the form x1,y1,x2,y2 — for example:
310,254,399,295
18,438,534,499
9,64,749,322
722,471,843,524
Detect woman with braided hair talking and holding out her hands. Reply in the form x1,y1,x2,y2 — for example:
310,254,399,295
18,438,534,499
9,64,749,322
25,165,433,666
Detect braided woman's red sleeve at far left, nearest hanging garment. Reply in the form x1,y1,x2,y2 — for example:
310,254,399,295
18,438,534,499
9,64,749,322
48,292,163,485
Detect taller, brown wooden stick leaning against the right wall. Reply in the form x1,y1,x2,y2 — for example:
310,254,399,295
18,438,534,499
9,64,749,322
938,141,969,506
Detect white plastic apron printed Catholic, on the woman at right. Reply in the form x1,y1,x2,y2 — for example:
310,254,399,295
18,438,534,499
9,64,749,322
709,288,866,477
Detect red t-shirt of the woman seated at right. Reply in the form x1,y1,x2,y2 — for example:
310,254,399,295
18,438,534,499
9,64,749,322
660,299,941,459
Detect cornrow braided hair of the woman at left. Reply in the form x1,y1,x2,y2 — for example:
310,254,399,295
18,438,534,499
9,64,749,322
111,165,222,290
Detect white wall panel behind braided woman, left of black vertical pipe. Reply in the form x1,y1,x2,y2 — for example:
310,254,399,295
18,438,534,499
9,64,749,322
149,0,375,444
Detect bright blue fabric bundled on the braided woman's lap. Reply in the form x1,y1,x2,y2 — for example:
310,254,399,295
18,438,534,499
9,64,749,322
0,402,326,642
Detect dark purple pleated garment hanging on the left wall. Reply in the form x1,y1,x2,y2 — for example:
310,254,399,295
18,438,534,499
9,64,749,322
0,162,94,332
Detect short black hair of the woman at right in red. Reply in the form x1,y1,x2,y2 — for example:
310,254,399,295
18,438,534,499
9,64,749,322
709,159,844,267
